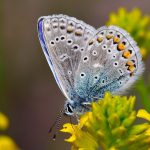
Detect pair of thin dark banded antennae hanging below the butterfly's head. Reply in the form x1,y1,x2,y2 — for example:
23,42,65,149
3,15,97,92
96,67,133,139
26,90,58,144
49,110,63,141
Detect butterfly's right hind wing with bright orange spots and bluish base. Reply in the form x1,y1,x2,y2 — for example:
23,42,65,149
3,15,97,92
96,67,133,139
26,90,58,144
75,26,144,101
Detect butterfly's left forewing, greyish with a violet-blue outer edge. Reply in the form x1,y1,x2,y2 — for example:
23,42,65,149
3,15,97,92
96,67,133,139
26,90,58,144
38,15,96,99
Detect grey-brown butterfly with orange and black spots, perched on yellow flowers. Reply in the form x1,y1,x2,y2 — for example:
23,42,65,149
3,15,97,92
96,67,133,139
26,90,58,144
38,14,144,116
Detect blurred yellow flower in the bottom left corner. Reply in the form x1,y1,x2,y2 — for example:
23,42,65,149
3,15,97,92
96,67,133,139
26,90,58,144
0,135,19,150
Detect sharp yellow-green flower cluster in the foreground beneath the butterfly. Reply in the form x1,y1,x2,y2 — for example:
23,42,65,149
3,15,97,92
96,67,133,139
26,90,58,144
61,93,150,150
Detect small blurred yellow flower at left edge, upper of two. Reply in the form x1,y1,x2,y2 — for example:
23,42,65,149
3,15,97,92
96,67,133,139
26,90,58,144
0,112,9,130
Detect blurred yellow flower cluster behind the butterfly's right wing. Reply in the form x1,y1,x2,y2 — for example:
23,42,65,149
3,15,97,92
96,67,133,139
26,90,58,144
107,8,150,58
